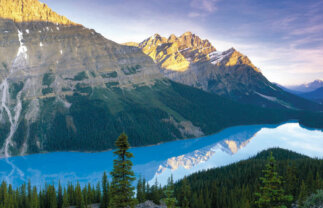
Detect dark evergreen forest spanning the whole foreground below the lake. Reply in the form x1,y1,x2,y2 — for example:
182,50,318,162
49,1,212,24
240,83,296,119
0,147,323,208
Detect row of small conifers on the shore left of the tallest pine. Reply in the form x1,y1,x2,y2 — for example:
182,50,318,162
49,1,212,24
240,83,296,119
0,173,110,208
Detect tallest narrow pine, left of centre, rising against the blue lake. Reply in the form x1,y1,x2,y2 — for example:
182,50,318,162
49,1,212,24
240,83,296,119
110,133,135,208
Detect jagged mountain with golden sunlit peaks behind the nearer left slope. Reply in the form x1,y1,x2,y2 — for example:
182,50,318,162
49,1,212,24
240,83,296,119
127,32,322,110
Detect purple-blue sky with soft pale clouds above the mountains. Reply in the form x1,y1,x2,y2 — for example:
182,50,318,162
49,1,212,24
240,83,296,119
42,0,323,85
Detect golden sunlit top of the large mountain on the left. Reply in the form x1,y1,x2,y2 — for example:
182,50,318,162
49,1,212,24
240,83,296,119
0,0,75,25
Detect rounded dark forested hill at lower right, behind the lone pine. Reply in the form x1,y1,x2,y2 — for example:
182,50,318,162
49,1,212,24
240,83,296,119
175,149,323,208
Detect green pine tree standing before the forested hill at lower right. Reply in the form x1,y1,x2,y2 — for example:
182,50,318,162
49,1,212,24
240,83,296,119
255,153,293,208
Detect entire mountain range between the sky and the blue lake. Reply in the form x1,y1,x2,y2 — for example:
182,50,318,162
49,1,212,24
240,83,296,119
0,0,323,157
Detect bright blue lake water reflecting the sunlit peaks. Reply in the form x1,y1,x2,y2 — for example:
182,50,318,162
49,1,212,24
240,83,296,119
0,122,323,187
